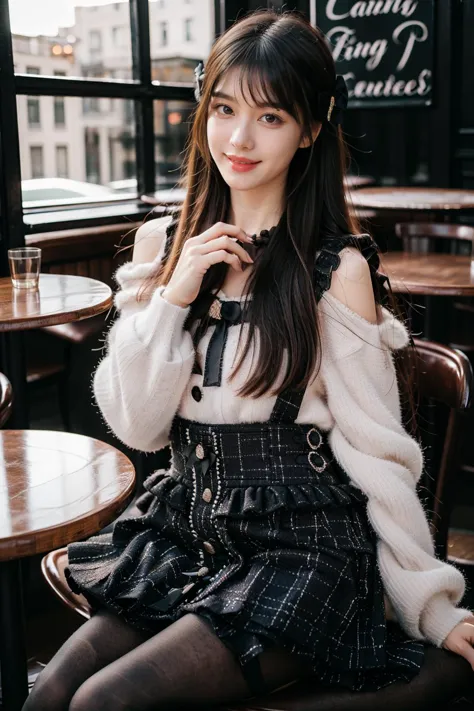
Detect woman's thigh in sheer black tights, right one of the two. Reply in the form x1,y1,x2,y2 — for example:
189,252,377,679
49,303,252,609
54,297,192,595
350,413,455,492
69,614,301,711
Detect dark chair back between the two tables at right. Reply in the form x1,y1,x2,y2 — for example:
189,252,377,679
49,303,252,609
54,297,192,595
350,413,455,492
395,222,474,254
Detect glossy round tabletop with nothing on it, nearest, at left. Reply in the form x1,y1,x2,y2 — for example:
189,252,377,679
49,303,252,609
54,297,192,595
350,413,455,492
0,430,135,562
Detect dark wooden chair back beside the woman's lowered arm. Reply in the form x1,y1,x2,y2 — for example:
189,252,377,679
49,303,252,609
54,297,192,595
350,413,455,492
403,339,473,559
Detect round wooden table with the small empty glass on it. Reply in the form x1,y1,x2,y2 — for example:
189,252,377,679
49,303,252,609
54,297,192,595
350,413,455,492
0,274,113,429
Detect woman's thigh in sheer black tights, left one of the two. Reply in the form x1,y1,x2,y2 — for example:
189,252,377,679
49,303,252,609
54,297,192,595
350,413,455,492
24,611,150,711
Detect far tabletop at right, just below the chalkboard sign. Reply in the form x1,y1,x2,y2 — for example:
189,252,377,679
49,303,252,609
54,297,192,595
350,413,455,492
351,186,474,212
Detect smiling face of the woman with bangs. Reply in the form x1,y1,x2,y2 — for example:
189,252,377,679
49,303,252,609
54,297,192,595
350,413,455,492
207,68,321,190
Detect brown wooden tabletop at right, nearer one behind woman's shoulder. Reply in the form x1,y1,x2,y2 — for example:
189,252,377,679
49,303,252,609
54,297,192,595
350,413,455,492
381,252,474,296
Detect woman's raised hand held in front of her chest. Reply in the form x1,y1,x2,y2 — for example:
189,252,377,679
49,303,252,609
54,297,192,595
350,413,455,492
162,222,253,308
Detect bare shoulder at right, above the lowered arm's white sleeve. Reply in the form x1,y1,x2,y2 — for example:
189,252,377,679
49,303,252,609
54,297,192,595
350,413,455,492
329,247,377,323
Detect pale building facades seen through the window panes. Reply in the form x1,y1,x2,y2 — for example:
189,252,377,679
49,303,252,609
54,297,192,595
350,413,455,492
13,0,214,192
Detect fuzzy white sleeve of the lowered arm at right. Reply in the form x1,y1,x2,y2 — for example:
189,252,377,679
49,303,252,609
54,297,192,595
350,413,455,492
320,293,470,646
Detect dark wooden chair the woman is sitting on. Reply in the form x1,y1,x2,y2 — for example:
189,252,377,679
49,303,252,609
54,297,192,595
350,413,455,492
42,340,474,711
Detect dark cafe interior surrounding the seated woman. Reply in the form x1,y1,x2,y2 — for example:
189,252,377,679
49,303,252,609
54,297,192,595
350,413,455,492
0,0,474,711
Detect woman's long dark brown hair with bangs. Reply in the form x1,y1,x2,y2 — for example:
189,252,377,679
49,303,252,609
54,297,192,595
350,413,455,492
139,10,412,412
